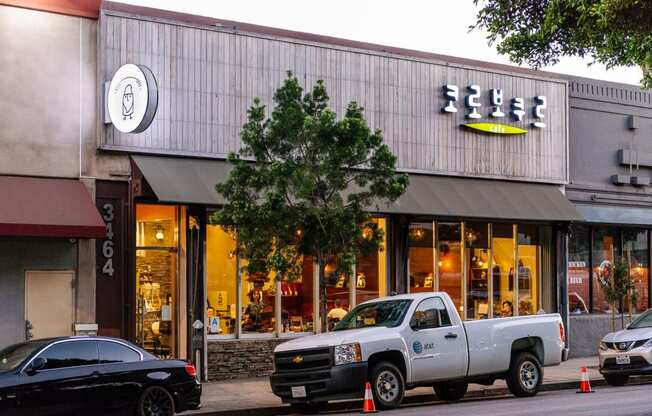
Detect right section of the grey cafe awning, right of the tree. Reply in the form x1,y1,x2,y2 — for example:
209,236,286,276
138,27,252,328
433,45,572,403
366,175,582,221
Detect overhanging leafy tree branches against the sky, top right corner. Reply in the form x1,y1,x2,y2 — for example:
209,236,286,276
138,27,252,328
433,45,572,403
471,0,652,88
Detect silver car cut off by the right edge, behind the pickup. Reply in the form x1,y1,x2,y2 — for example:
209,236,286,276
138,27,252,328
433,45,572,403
599,309,652,386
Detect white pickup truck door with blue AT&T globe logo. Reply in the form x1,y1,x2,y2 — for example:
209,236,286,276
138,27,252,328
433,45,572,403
407,296,468,382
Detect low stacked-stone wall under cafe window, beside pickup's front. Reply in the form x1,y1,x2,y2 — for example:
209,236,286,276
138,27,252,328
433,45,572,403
208,339,287,381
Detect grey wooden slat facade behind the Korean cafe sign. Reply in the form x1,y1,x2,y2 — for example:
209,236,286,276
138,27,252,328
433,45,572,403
99,11,568,183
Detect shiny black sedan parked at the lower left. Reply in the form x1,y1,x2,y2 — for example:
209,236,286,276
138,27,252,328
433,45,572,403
0,337,201,416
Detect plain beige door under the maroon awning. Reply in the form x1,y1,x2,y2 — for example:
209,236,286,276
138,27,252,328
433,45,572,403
25,270,75,338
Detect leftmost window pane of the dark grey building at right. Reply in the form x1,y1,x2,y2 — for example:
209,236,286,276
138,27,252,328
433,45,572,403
568,225,591,315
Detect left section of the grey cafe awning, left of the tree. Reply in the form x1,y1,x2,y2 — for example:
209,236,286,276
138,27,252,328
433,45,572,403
131,156,231,205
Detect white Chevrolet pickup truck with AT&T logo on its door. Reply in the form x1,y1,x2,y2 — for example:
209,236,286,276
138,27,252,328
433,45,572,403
270,292,568,410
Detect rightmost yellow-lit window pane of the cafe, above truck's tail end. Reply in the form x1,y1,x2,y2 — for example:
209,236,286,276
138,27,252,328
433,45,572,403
517,224,540,315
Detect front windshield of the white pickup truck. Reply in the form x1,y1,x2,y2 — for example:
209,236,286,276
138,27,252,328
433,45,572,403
333,299,412,331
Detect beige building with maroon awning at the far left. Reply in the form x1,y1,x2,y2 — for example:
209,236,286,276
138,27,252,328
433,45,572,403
0,0,113,348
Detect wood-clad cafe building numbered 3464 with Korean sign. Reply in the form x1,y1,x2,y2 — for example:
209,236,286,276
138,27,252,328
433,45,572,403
91,2,581,379
